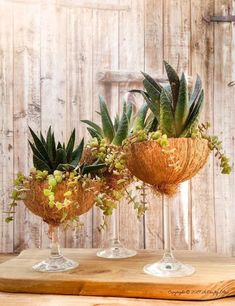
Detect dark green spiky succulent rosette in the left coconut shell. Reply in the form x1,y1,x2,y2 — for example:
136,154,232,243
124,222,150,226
29,127,104,174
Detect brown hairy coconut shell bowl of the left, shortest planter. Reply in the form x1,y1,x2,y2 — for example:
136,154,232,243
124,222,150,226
24,179,101,226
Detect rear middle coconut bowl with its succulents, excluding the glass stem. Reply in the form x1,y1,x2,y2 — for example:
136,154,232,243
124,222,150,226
82,96,146,220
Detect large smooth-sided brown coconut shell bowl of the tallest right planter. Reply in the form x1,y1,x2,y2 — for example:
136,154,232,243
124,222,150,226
127,138,210,196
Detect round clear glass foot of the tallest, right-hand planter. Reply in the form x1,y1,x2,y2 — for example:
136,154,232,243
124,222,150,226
144,261,195,277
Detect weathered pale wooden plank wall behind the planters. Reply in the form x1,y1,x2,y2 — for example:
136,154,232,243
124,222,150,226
0,0,235,255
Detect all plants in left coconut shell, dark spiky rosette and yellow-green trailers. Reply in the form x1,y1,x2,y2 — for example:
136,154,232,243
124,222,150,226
6,127,105,222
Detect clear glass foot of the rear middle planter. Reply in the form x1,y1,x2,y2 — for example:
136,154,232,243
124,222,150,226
96,244,137,259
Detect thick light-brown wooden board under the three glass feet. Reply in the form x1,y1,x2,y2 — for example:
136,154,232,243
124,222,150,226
0,249,235,300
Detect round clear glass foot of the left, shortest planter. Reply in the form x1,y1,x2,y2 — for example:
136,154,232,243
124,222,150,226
33,255,79,272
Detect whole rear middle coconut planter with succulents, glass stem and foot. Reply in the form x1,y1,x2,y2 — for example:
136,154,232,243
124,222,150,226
82,96,136,259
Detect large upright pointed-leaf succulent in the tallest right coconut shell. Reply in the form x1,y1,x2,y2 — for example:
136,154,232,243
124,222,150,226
132,62,204,138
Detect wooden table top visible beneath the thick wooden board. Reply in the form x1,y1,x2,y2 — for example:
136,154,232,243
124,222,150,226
0,254,235,306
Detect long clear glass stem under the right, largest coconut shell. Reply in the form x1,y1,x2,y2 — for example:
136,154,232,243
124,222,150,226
163,198,174,260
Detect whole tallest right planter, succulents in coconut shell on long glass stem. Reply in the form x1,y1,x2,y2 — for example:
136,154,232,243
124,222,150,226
124,62,231,277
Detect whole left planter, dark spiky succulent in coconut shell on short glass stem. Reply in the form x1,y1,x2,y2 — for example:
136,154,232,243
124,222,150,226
7,128,104,272
